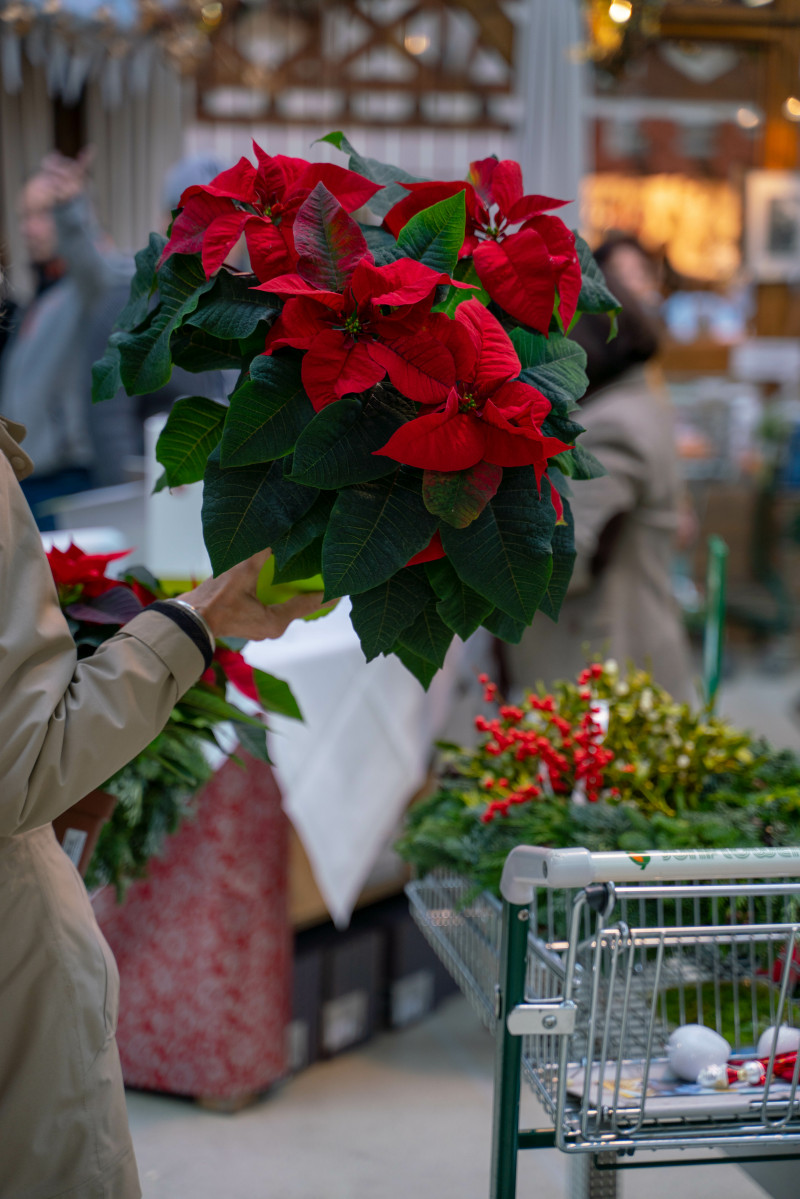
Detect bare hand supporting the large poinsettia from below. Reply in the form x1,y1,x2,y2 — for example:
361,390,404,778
178,549,337,641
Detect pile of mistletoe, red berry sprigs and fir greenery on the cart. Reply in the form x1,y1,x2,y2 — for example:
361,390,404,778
398,661,800,890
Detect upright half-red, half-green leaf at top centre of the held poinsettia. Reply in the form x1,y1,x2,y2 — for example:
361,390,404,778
291,183,367,291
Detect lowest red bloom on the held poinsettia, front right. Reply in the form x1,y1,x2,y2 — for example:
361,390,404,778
375,300,570,483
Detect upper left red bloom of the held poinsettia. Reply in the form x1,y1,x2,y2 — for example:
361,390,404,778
161,141,383,283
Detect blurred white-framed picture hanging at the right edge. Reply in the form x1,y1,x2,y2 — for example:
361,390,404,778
745,170,800,283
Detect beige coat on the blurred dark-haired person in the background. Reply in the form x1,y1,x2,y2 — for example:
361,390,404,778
507,368,692,699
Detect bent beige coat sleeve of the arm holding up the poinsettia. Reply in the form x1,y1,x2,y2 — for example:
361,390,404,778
0,452,204,837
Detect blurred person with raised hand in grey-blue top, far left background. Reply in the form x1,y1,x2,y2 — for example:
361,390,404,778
0,149,130,529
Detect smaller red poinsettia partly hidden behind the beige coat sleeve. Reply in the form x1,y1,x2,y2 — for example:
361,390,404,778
47,543,300,761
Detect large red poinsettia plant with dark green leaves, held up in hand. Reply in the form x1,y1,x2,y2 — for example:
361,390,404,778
94,133,618,686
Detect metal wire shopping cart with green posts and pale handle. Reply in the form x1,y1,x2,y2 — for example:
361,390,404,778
408,846,800,1199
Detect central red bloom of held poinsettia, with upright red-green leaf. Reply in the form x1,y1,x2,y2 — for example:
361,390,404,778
263,188,465,411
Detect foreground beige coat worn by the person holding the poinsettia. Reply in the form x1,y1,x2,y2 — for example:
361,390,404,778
0,418,203,1199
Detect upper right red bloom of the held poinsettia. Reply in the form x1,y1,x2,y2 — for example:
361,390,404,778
384,158,581,333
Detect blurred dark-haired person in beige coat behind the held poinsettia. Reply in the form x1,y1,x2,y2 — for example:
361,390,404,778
513,237,693,700
